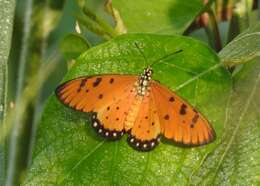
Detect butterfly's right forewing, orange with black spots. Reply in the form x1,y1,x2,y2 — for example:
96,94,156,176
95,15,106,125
151,81,215,146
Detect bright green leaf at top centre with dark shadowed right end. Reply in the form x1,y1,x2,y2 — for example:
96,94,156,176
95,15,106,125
112,0,204,34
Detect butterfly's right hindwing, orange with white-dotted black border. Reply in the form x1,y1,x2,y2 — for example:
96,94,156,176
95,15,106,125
127,94,161,151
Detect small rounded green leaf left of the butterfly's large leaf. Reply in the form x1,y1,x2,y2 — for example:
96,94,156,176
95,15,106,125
60,34,90,60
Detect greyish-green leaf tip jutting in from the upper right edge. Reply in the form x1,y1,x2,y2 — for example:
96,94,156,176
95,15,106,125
219,23,260,66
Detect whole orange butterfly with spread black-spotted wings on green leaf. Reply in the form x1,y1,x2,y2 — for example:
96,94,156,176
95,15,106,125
56,46,215,151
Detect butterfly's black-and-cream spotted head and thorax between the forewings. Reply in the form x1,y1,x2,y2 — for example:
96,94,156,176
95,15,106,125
137,67,153,96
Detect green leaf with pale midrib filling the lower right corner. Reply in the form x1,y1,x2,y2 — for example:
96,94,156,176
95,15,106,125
191,60,260,185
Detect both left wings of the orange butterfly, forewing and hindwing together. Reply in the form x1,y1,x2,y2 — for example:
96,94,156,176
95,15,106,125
56,75,138,140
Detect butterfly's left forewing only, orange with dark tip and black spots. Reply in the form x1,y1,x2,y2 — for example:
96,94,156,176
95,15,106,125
56,75,137,112
